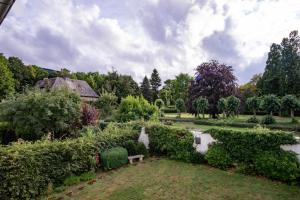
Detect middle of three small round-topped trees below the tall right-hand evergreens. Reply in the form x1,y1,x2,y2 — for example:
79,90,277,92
261,94,280,116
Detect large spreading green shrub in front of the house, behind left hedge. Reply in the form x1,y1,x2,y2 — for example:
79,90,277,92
0,90,81,140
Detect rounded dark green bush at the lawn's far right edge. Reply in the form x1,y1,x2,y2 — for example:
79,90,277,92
255,150,300,182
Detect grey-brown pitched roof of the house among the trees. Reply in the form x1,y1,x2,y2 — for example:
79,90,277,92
37,77,99,101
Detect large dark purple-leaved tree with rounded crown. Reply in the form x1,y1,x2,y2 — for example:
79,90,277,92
187,60,237,118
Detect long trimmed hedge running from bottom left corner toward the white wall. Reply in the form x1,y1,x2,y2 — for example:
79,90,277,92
0,124,139,199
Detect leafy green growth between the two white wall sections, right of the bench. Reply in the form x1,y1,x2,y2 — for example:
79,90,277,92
146,124,194,162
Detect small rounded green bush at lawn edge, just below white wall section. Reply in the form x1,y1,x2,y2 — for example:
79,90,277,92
205,144,233,170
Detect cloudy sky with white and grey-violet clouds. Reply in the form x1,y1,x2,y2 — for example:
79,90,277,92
0,0,300,83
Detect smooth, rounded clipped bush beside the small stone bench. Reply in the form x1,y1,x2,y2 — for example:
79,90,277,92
101,147,128,170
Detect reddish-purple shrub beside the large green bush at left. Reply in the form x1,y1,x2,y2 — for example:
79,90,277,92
81,104,100,126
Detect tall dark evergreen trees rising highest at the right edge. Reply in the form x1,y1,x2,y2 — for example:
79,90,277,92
258,31,300,96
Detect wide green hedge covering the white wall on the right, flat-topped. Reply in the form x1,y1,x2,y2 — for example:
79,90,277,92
207,128,297,164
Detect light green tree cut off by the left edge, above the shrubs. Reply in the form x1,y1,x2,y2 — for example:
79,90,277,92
0,54,15,101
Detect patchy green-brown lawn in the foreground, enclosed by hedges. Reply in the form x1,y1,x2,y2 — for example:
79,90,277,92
51,158,300,200
